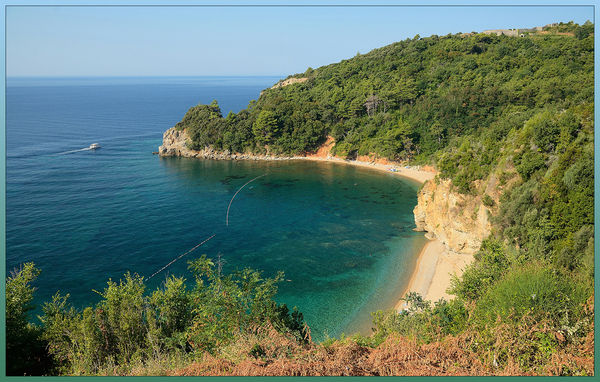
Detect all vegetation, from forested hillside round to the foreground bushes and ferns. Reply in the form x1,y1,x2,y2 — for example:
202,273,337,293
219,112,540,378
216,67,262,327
6,23,594,375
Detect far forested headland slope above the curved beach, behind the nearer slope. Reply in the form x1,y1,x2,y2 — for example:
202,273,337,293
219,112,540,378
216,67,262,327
177,24,593,174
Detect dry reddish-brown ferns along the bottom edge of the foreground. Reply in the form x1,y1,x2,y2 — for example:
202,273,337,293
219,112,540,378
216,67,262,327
171,314,594,376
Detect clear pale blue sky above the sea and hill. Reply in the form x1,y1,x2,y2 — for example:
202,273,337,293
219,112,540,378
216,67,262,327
6,6,594,76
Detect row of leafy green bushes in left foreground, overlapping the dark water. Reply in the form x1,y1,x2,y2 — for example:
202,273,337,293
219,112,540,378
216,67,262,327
42,255,310,375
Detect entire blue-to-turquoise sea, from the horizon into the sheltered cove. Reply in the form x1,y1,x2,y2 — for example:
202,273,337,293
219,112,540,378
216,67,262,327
6,77,425,339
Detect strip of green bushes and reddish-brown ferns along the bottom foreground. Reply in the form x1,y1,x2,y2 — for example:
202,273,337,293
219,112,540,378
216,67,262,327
7,255,594,375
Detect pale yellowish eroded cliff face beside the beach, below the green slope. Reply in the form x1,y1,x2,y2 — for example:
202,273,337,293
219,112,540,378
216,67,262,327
414,179,491,255
